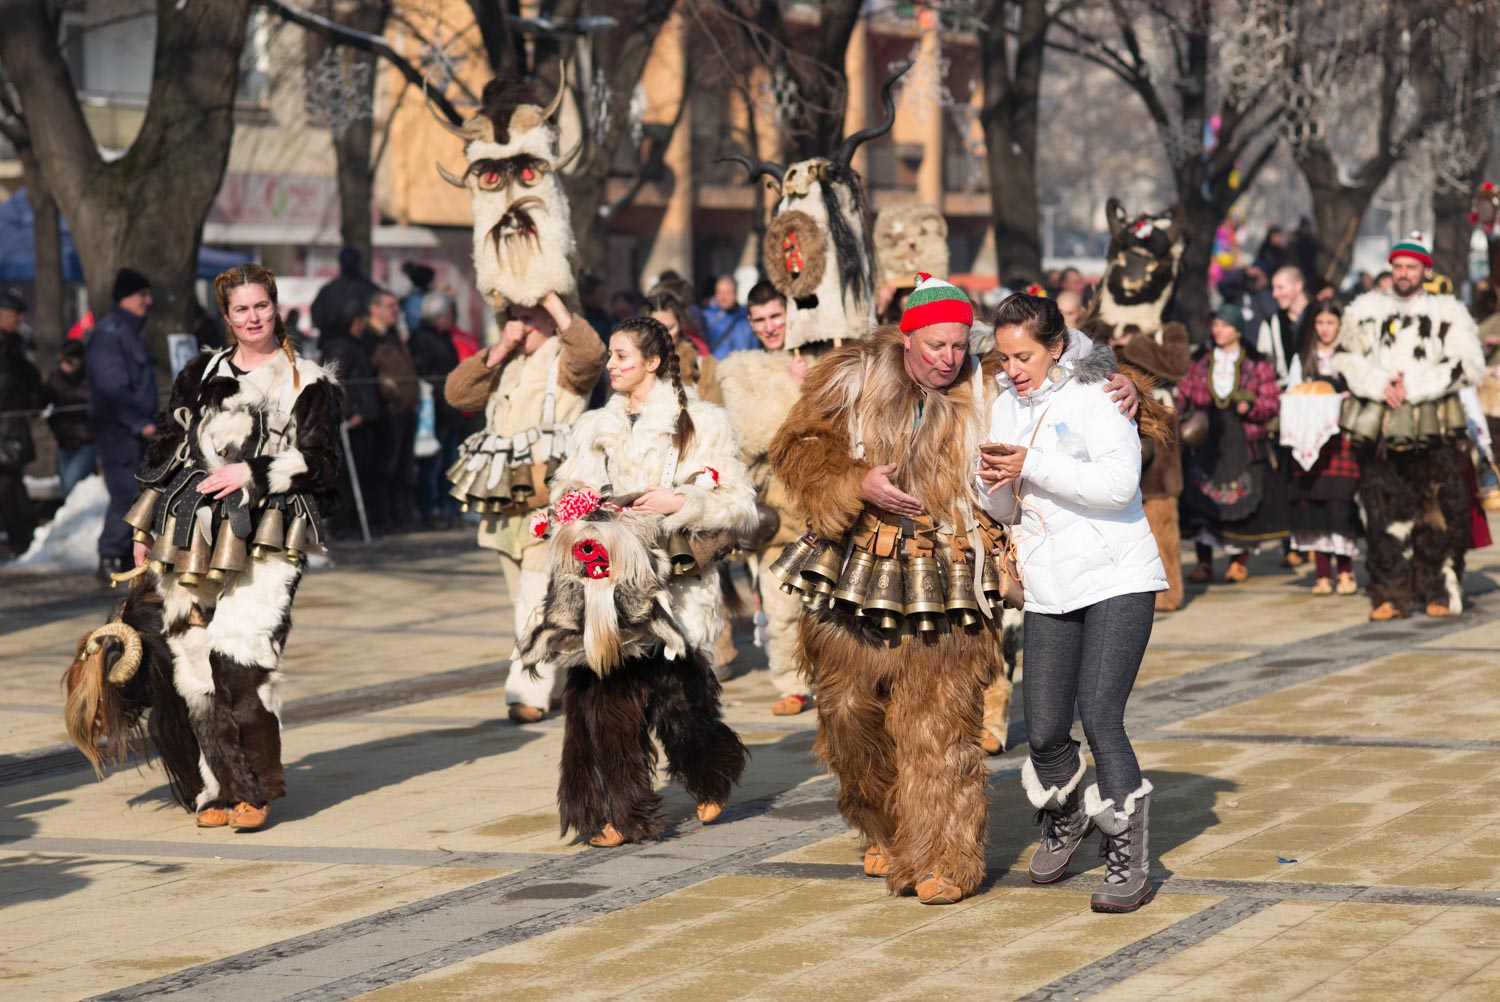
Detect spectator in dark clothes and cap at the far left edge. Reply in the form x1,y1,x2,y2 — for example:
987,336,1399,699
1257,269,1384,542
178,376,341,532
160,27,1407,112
0,293,41,557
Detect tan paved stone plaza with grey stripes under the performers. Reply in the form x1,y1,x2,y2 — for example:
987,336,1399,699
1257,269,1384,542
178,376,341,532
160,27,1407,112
0,525,1500,1002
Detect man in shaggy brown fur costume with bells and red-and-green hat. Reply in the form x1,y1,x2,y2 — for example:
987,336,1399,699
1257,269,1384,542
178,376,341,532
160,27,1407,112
770,276,1140,905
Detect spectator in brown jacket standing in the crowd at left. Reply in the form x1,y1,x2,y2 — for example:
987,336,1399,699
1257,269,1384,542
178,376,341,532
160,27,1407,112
365,288,422,533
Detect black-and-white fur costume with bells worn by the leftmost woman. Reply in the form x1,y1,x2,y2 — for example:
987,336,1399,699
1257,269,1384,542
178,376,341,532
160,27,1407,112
75,348,342,812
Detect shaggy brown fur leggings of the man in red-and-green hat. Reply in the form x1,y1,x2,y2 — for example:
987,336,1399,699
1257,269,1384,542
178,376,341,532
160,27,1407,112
801,611,1001,894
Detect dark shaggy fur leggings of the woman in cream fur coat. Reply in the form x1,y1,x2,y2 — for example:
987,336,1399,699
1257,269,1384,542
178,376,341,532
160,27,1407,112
558,650,749,842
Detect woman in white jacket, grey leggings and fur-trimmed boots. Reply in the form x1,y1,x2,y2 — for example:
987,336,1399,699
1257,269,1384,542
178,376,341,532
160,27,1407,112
978,294,1167,912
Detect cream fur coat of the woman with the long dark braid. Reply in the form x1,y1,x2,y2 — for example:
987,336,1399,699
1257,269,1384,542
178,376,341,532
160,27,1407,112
552,380,756,651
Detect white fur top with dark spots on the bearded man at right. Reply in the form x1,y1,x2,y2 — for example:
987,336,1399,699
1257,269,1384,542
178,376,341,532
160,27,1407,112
1334,290,1485,404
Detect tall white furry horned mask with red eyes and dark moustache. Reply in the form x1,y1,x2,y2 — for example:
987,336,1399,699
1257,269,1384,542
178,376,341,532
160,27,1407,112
438,78,582,309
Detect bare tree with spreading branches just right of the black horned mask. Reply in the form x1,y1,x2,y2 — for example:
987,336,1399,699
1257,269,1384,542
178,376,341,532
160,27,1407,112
1047,0,1286,336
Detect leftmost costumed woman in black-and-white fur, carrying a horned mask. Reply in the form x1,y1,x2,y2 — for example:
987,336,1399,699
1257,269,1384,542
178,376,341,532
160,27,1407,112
68,264,342,831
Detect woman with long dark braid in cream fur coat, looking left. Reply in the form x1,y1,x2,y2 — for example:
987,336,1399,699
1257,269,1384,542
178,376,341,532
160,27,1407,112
542,317,756,848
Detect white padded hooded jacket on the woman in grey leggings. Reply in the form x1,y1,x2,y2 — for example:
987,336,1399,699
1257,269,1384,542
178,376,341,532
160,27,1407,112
980,330,1167,615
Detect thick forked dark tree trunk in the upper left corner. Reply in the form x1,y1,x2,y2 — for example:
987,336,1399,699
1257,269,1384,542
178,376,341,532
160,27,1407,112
0,0,249,359
